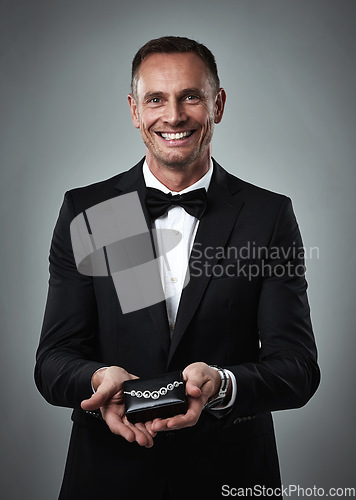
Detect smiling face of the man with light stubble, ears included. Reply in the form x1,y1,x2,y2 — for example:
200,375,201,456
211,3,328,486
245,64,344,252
129,52,225,169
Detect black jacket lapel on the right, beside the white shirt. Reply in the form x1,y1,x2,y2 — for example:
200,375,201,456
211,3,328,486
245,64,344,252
168,161,243,364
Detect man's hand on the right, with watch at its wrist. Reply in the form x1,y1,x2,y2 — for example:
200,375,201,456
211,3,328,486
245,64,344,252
146,363,231,433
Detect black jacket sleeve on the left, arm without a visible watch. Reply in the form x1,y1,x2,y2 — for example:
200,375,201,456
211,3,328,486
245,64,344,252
35,192,105,408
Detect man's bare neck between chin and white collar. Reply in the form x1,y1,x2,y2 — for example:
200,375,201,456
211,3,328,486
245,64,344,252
146,151,211,192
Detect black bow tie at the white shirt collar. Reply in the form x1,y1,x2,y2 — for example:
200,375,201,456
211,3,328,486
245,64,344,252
146,188,206,219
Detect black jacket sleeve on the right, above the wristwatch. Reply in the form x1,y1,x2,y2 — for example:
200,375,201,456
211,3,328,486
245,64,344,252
228,198,320,418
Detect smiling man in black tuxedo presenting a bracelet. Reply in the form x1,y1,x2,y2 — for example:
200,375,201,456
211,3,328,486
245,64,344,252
35,37,320,500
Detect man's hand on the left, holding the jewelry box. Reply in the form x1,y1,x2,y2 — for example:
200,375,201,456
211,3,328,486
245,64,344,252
81,366,156,448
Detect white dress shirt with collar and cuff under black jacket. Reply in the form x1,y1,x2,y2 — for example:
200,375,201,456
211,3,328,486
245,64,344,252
143,161,237,410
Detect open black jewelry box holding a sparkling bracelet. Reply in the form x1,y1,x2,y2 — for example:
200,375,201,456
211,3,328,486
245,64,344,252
124,371,187,424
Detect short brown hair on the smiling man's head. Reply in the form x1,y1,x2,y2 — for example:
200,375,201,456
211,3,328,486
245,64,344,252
131,36,220,96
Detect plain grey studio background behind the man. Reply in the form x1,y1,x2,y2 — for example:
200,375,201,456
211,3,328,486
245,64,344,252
0,0,356,500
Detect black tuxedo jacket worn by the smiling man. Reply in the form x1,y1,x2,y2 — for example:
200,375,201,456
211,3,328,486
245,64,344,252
35,160,320,500
